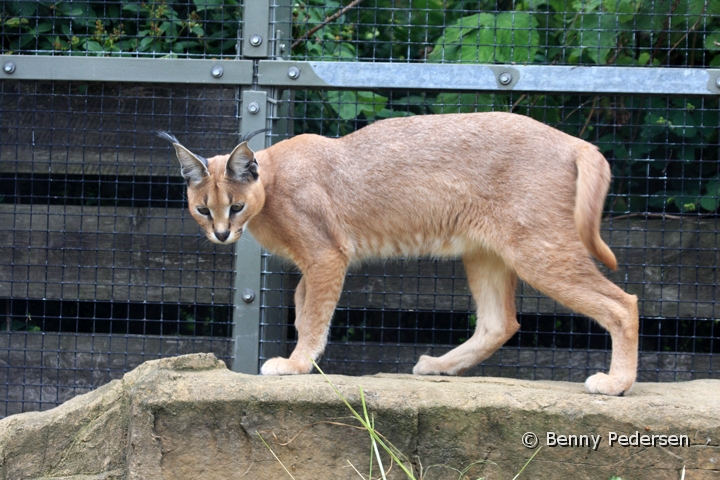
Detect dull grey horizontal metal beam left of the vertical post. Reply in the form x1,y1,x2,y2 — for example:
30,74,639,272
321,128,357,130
0,55,253,85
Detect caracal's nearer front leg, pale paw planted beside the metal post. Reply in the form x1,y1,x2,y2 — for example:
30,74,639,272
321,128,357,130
260,254,347,375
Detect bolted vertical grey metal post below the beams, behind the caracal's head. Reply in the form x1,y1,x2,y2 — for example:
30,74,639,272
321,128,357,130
232,90,268,375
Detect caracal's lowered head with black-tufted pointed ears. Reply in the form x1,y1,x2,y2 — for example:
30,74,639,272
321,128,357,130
158,132,265,244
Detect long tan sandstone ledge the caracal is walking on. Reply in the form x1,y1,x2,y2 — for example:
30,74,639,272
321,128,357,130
0,354,720,480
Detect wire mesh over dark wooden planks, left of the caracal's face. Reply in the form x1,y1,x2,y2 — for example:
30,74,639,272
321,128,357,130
0,81,243,415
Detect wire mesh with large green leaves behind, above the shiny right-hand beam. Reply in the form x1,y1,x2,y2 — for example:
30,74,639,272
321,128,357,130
284,0,720,66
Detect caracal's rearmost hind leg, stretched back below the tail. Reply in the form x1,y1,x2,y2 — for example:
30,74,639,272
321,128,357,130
517,248,639,395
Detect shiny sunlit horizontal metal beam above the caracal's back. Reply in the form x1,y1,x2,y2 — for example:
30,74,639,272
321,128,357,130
258,61,720,95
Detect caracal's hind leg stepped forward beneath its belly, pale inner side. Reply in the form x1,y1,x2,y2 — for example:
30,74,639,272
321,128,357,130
413,252,520,375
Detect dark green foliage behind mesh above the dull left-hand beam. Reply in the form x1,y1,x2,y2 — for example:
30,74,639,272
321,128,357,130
0,0,241,56
